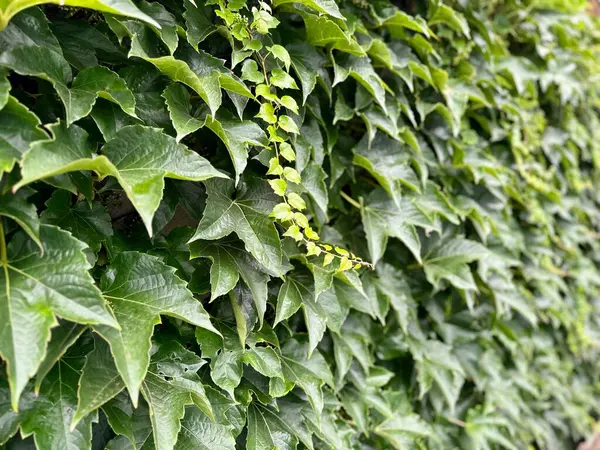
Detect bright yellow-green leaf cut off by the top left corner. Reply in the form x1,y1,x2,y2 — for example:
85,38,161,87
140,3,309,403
0,0,160,30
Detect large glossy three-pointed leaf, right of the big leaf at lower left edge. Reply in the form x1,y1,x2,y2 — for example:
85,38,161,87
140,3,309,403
96,252,219,405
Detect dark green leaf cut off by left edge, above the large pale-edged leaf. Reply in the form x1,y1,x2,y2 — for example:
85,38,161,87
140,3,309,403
0,97,48,176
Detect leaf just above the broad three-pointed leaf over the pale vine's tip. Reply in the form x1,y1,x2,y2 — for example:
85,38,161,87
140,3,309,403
352,134,420,207
